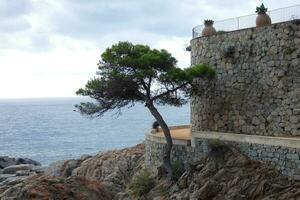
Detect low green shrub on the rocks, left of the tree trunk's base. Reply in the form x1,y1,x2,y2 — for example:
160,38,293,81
129,170,155,196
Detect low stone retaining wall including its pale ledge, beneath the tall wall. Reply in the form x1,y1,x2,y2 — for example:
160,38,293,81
145,132,300,176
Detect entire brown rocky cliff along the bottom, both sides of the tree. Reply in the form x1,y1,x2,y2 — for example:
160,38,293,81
0,144,300,200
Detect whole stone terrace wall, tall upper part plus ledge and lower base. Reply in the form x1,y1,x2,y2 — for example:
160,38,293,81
145,20,300,176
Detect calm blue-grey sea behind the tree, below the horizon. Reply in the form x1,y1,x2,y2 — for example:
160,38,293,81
0,98,190,165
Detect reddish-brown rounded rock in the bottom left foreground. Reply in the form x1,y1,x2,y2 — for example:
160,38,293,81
0,176,112,200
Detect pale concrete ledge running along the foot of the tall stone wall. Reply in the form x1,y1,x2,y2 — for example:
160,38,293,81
192,131,300,148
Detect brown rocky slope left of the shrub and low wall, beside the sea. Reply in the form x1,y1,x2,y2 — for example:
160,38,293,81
0,144,144,200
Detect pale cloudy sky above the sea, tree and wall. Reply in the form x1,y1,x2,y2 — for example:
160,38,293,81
0,0,300,99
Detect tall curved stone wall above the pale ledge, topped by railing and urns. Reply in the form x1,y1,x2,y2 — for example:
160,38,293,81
191,21,300,136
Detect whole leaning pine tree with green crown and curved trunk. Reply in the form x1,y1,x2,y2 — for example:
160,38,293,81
76,42,215,177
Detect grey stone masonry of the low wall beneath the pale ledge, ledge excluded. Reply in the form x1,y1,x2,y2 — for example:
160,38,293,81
145,138,300,176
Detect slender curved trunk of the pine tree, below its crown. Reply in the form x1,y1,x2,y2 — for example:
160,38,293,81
146,102,173,179
